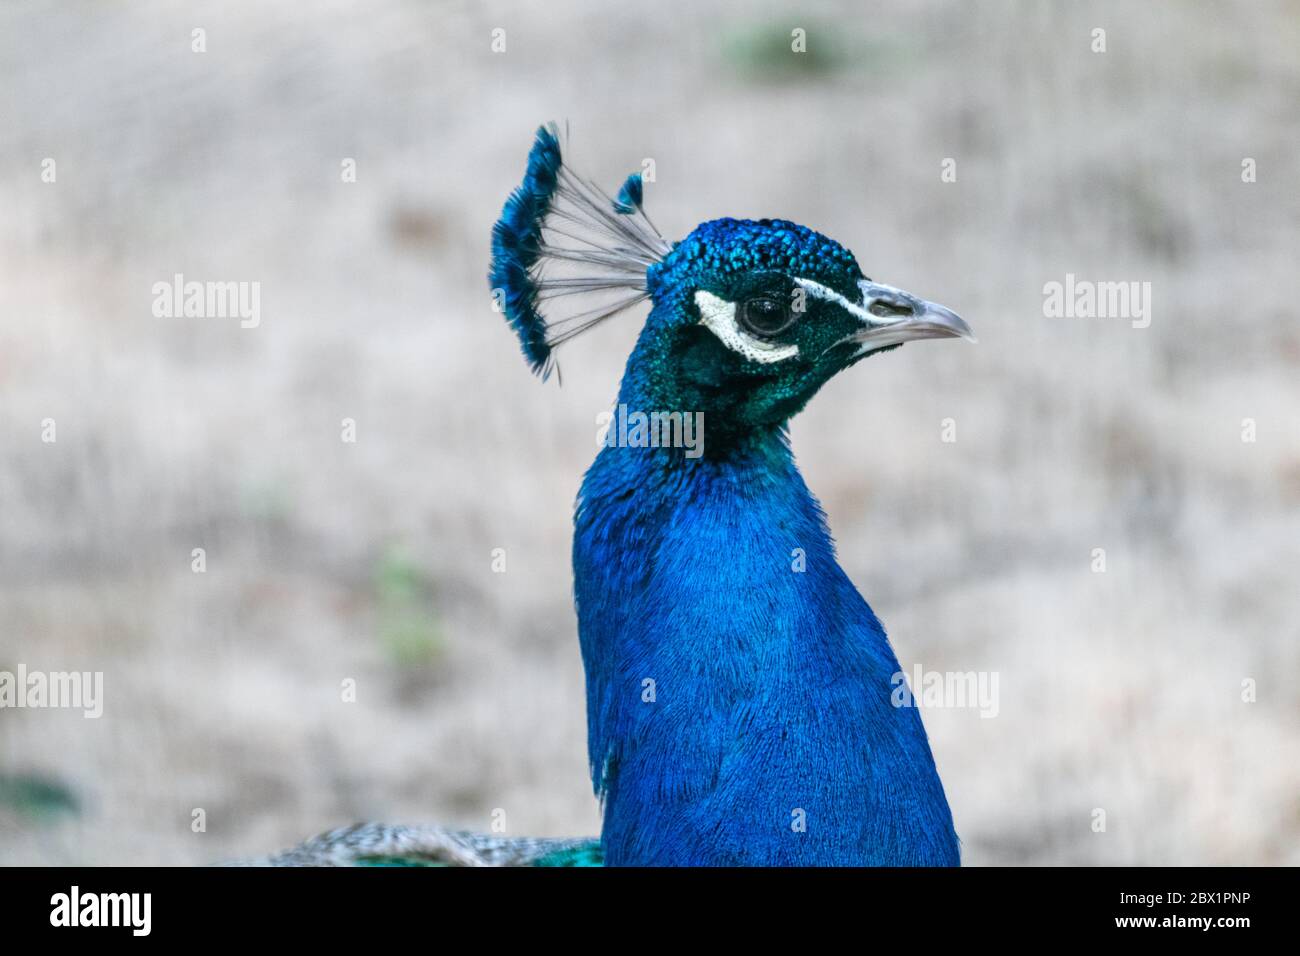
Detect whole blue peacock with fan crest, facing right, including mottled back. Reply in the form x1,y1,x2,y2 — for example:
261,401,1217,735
269,125,974,866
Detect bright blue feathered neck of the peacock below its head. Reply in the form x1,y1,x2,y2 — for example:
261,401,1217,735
573,389,958,865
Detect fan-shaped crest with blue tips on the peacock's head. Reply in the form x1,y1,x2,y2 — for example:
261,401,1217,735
488,124,672,378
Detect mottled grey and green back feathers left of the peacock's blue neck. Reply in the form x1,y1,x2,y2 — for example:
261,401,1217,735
238,823,601,866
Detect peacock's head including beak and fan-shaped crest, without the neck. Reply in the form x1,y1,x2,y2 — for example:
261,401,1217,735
490,126,974,434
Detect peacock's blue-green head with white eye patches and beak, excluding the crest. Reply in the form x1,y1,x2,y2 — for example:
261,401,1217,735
628,219,972,427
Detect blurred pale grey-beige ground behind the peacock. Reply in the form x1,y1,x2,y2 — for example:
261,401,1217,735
0,0,1300,865
